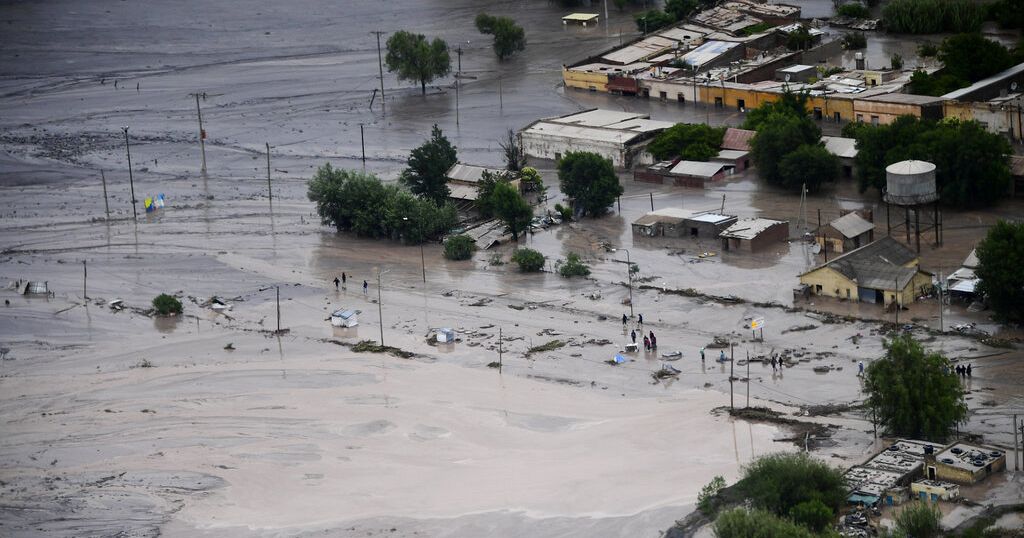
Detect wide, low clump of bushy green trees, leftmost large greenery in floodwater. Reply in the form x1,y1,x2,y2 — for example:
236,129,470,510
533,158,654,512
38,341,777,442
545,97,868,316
307,164,457,243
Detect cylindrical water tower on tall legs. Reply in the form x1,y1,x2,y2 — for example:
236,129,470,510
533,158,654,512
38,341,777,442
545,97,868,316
883,160,942,254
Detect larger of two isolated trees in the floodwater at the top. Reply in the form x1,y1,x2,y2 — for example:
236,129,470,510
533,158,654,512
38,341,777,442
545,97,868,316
384,30,452,95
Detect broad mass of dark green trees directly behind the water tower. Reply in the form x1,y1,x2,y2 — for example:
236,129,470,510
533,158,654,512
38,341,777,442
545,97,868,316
844,116,1012,207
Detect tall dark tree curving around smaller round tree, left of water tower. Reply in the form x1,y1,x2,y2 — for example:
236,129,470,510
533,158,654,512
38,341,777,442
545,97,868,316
751,113,821,190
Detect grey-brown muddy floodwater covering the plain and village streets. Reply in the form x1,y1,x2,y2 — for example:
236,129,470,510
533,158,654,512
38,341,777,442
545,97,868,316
0,0,1024,537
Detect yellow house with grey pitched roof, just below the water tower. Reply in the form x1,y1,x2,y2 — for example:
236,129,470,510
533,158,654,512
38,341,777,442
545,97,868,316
800,236,932,304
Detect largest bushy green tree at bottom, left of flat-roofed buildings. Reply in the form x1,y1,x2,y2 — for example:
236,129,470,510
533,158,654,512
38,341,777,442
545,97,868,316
735,453,847,515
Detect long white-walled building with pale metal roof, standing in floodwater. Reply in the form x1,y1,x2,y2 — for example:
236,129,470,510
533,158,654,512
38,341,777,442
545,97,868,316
519,109,675,168
